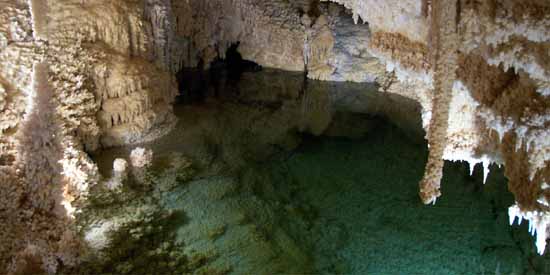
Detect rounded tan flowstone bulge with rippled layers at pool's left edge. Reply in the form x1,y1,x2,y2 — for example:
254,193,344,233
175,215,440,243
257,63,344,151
92,56,176,146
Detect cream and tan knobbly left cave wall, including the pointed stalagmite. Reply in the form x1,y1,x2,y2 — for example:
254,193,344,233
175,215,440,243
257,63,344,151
0,0,177,273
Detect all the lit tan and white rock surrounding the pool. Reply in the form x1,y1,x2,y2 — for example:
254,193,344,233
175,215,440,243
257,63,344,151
0,0,550,271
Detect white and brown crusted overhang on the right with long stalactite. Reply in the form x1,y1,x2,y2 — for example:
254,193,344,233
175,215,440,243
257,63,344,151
322,0,550,252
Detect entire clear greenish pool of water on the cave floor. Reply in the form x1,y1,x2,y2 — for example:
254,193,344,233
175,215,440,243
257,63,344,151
88,70,550,274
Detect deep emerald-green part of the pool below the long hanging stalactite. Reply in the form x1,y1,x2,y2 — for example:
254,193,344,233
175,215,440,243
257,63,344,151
248,127,533,274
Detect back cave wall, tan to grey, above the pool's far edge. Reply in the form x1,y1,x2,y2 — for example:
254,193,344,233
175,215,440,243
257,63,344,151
170,0,386,82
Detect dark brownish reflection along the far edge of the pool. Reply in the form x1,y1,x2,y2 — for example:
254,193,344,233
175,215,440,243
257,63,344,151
94,69,424,176
